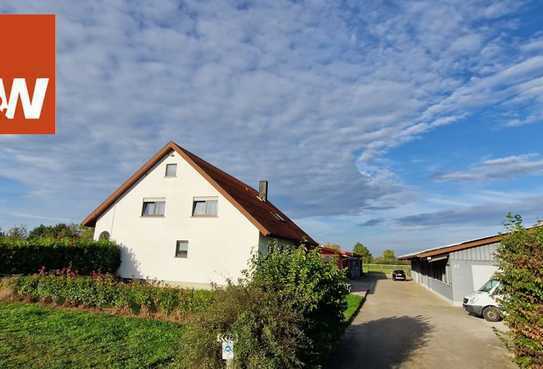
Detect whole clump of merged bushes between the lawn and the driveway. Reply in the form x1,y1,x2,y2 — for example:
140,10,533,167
183,249,348,369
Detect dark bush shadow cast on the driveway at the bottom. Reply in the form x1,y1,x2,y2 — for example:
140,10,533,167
327,315,431,369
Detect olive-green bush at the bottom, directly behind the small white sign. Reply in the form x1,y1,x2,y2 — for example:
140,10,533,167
181,284,308,369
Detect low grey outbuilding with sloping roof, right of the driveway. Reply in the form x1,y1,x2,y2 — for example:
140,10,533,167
400,235,503,305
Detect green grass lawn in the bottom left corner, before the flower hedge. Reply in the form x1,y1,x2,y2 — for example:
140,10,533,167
0,303,183,369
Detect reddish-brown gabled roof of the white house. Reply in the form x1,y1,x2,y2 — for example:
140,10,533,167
81,142,317,245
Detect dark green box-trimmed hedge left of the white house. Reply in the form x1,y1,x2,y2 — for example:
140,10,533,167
0,238,121,275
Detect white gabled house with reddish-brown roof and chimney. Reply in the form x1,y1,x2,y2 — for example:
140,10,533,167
82,142,316,287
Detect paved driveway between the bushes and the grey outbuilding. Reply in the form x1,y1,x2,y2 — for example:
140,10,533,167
329,277,516,369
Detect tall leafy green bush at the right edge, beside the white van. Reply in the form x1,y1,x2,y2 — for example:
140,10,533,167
498,216,543,368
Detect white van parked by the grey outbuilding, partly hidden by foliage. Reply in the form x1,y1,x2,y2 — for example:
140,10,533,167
462,277,502,322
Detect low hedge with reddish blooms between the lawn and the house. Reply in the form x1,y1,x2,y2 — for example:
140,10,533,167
2,272,213,321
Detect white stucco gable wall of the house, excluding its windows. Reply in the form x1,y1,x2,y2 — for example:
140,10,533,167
94,153,260,285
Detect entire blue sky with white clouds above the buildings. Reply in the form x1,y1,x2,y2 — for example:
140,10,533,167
0,0,543,254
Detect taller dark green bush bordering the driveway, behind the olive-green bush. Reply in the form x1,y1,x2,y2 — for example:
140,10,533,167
252,244,349,365
